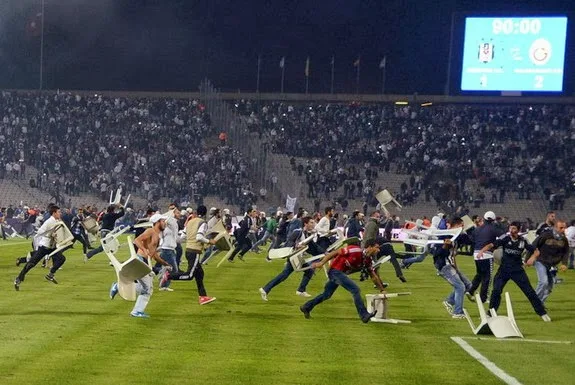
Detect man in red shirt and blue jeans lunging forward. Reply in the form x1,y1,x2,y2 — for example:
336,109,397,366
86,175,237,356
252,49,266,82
300,239,385,323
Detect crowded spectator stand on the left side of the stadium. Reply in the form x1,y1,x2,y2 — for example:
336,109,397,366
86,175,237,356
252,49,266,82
0,92,254,210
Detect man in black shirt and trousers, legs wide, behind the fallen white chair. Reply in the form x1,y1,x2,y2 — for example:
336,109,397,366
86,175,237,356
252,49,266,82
479,222,551,322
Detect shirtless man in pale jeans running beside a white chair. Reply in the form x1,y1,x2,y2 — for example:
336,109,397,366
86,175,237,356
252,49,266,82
110,214,172,318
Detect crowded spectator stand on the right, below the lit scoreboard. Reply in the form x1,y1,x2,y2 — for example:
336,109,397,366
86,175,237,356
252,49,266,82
235,101,575,210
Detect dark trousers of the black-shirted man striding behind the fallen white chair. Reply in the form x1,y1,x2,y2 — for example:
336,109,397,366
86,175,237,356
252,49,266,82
489,266,547,315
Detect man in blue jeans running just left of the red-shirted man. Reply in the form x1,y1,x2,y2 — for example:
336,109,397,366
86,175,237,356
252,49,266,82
259,217,325,301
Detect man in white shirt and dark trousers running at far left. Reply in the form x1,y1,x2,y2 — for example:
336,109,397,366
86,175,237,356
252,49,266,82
14,205,66,291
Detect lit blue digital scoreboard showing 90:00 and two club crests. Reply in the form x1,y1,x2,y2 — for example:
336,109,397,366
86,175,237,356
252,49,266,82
461,16,567,92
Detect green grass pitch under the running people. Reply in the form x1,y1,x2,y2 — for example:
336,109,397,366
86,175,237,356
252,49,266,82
0,240,575,385
